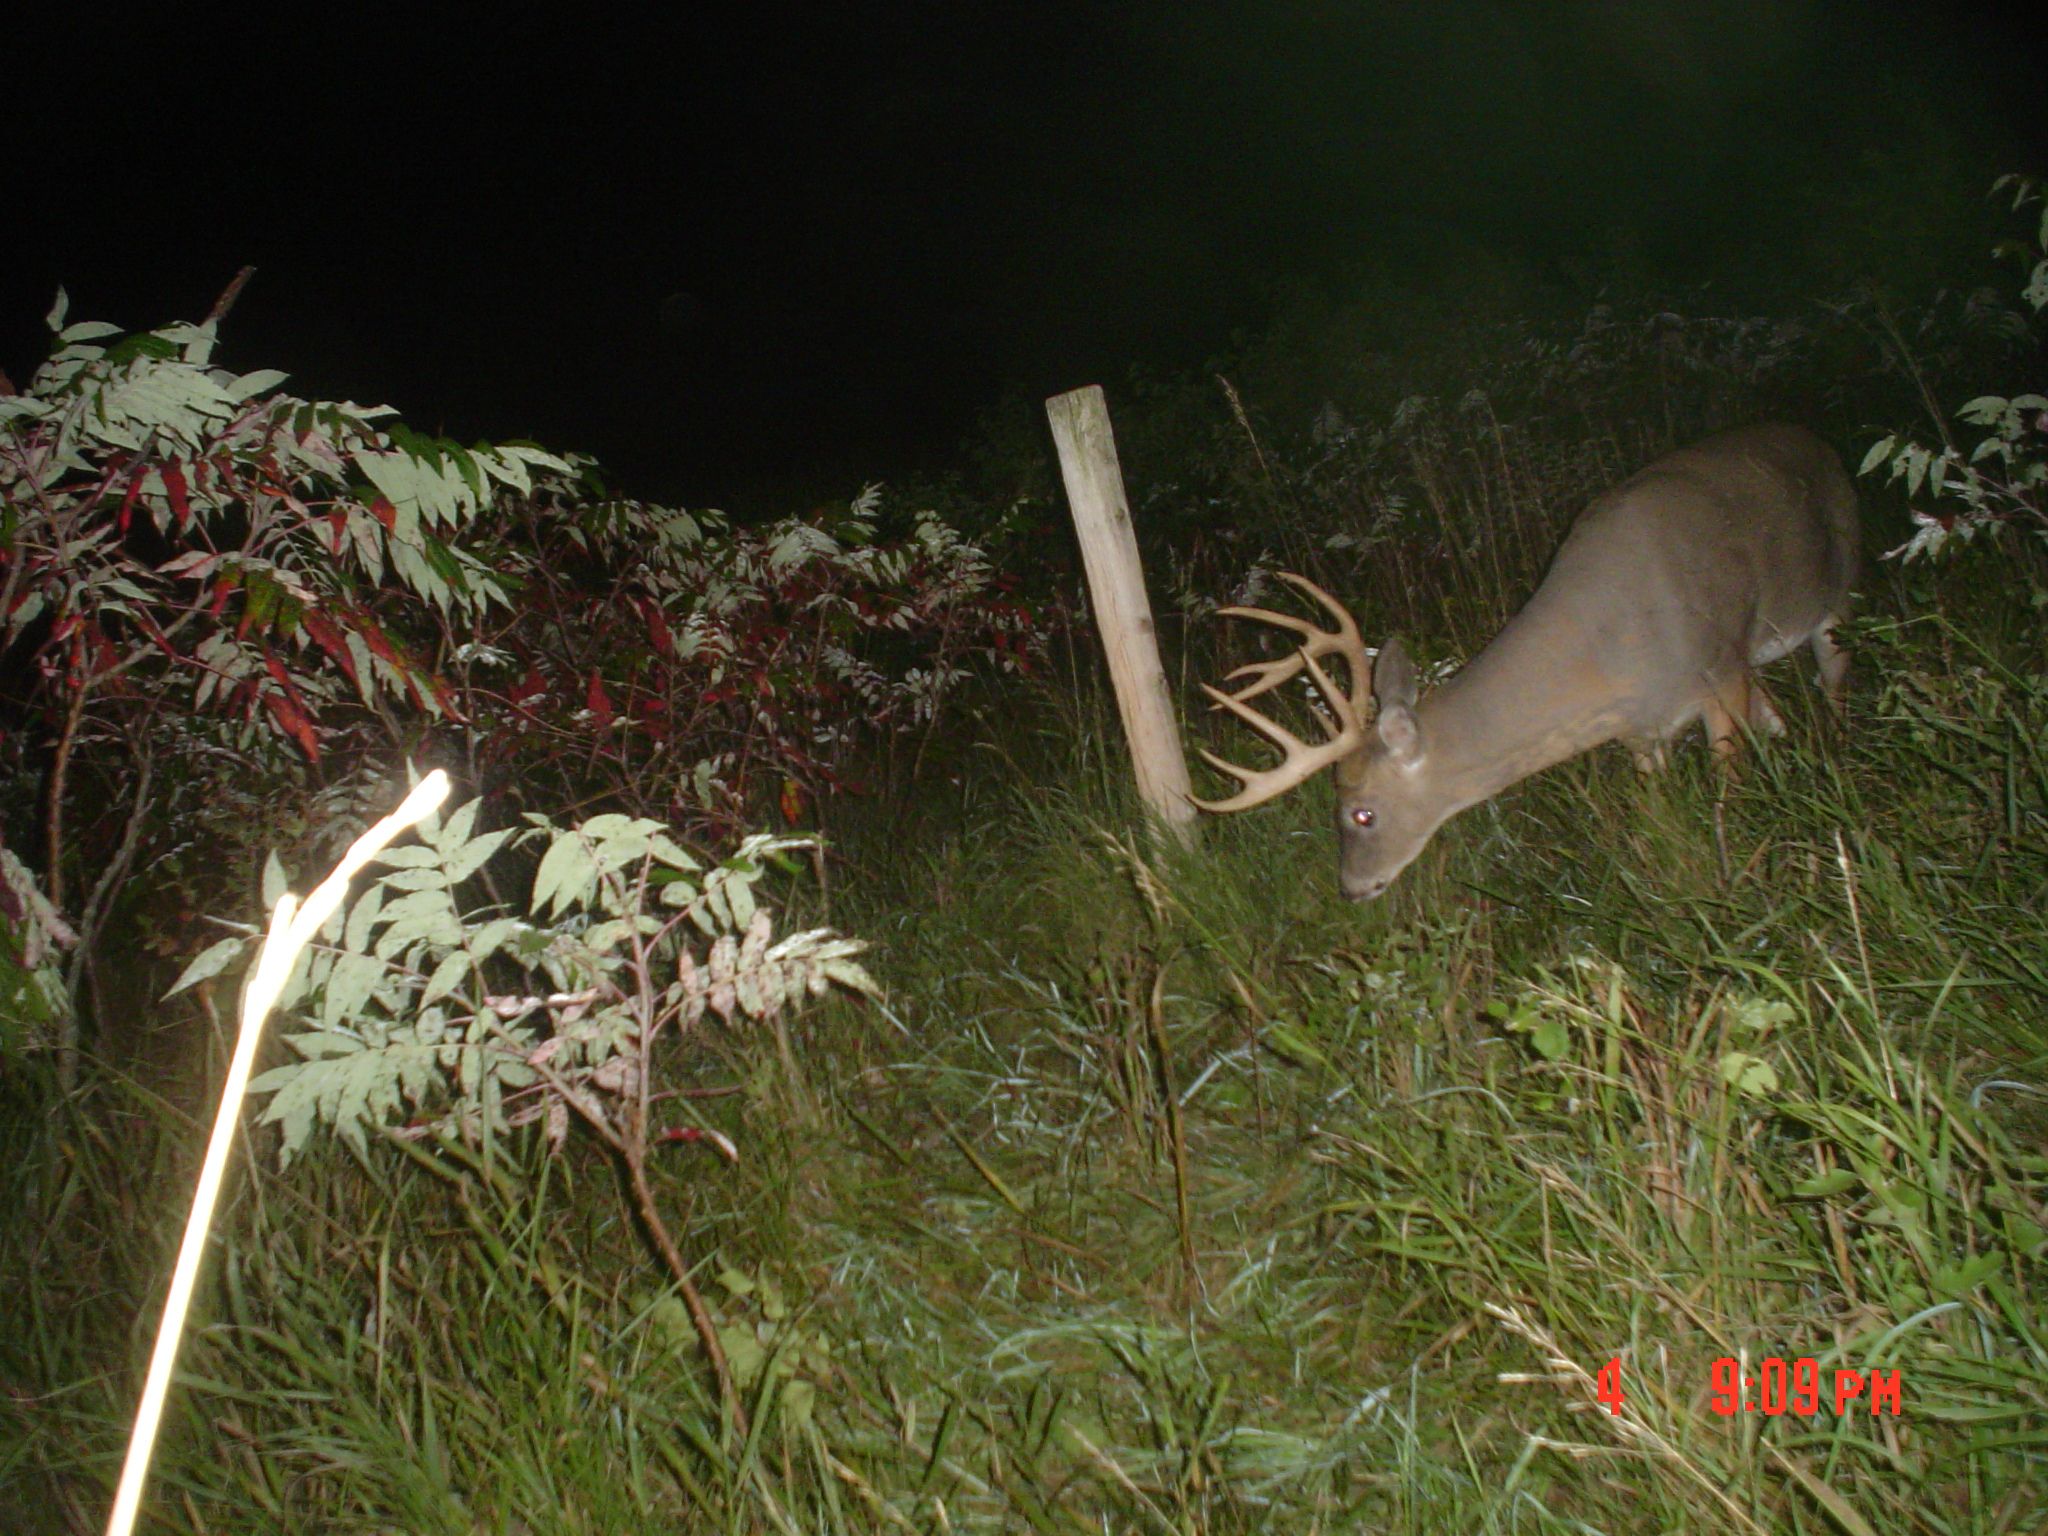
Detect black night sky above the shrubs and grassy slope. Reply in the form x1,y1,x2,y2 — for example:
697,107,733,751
0,0,2048,510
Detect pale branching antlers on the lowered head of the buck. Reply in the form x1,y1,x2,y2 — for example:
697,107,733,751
1194,571,1372,811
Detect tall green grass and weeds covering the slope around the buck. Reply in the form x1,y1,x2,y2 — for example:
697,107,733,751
0,198,2048,1534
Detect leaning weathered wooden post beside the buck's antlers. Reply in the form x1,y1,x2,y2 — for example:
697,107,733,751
1044,385,1196,846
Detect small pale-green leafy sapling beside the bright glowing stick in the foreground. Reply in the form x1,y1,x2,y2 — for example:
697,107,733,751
172,801,877,1423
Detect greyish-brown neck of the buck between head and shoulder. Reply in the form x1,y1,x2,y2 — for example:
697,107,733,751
1417,602,1628,811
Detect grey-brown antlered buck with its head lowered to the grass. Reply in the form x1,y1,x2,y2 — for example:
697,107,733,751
1196,426,1858,901
